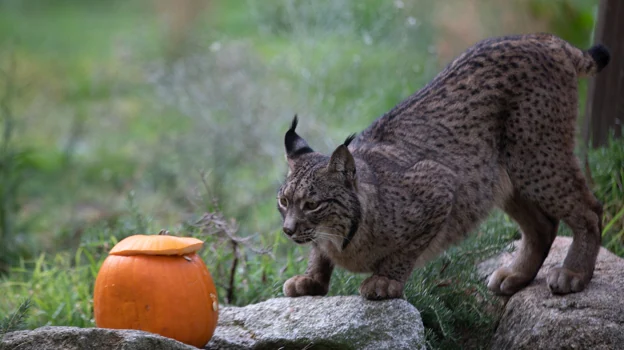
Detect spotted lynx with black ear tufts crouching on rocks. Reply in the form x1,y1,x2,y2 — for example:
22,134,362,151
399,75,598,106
277,34,610,300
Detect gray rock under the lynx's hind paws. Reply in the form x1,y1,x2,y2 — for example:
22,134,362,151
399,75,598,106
480,237,624,350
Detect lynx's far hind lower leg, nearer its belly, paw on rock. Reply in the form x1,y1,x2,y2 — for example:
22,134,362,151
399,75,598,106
488,193,559,295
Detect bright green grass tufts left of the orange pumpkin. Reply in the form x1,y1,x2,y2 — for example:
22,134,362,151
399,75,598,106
0,196,154,328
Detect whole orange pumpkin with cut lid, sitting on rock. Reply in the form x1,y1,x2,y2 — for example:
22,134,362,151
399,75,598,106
93,235,219,347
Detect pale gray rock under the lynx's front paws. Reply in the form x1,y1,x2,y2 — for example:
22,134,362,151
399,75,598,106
206,296,425,350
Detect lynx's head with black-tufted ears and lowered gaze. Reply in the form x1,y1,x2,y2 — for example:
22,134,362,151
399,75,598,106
277,116,362,249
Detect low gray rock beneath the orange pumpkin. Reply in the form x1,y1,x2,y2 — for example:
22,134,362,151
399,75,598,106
0,326,197,350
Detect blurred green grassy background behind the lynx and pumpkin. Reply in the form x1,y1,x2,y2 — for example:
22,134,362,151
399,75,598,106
0,0,622,346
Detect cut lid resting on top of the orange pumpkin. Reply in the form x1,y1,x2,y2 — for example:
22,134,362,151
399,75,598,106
109,235,204,256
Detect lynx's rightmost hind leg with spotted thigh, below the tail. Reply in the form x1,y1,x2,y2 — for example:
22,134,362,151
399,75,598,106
502,62,602,294
